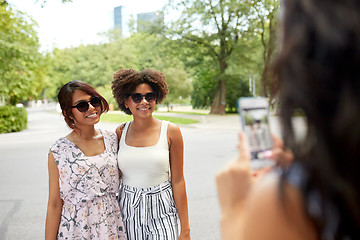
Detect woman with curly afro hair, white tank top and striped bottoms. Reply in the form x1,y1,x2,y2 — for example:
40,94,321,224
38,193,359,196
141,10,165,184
112,69,190,240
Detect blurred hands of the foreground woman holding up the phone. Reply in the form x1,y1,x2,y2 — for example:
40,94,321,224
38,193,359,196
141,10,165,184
216,132,294,240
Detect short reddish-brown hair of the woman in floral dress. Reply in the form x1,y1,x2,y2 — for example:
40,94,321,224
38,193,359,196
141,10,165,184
58,81,109,129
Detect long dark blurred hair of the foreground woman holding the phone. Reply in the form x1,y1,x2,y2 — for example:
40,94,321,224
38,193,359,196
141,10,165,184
274,0,360,239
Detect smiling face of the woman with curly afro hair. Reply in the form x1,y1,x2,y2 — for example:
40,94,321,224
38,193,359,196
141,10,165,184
125,83,156,118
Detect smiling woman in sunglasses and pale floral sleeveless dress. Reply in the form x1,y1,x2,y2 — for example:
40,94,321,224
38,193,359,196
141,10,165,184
45,81,126,240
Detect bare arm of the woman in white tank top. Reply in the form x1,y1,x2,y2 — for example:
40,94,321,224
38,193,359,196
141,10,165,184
168,123,190,239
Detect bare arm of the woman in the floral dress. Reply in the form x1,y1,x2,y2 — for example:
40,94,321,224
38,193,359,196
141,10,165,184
45,152,63,240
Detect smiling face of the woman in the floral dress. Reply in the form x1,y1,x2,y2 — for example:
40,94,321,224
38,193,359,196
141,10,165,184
72,90,101,126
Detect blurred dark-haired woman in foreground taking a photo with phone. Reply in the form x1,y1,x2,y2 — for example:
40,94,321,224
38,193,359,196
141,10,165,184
217,0,360,240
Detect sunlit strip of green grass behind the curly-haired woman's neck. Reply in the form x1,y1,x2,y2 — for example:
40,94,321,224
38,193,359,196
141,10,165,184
101,113,198,125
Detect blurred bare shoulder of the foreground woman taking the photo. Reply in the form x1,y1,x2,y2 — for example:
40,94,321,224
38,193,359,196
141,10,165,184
243,174,316,240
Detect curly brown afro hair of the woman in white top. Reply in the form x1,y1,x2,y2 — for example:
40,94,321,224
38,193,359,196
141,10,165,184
111,69,168,115
